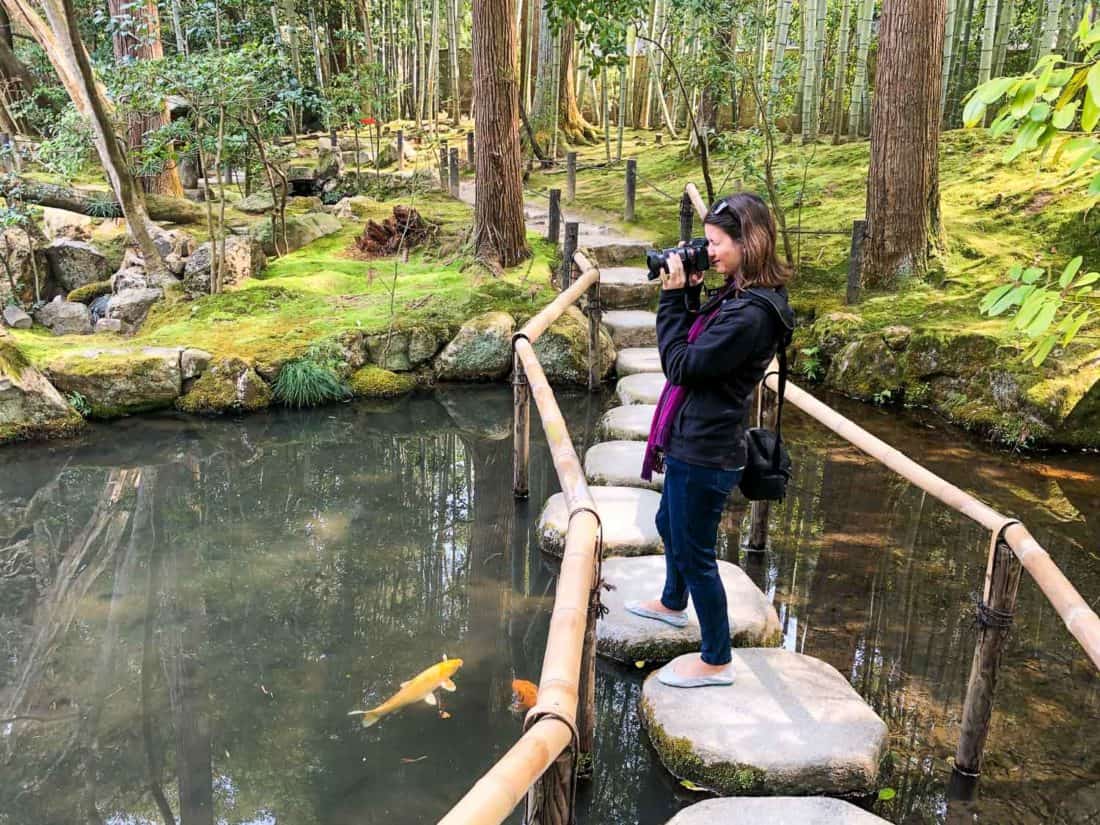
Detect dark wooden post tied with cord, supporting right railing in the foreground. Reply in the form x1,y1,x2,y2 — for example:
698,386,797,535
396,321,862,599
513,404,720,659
955,534,1023,777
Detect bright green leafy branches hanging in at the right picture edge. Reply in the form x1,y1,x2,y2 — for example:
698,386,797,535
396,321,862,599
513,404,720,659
963,6,1100,366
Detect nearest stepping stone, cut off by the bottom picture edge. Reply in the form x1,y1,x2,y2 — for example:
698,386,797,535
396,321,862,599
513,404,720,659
666,796,890,825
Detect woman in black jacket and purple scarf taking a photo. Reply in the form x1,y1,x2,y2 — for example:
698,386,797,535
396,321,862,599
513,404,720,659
626,193,793,688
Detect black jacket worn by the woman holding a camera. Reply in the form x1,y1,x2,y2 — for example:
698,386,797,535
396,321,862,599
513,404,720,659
657,287,794,470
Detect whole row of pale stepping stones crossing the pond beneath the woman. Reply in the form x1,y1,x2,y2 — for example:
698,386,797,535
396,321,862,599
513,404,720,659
539,275,887,825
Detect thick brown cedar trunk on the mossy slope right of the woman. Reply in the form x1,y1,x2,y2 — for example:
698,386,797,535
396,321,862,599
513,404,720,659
861,0,946,288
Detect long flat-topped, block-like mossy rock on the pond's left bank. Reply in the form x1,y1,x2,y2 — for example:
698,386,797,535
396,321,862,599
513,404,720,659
45,347,183,418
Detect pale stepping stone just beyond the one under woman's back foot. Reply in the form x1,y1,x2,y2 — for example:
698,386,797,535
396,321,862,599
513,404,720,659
539,487,664,558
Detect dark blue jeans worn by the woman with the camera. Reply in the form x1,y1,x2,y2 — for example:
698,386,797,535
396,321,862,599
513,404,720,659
657,458,741,664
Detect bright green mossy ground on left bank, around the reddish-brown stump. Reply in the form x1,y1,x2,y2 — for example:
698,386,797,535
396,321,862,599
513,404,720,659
14,194,554,364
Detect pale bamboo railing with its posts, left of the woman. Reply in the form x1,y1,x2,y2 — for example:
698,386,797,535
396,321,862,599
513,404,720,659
439,252,600,825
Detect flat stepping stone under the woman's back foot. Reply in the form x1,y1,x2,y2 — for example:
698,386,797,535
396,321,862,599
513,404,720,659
596,556,782,663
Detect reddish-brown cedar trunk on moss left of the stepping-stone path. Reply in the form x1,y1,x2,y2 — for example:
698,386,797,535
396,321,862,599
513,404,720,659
472,0,530,267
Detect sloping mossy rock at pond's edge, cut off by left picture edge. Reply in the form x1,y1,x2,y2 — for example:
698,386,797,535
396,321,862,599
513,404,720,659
0,330,84,443
